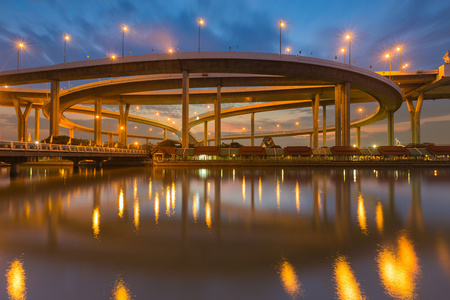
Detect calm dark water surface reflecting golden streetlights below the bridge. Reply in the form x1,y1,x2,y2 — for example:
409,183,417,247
0,167,450,299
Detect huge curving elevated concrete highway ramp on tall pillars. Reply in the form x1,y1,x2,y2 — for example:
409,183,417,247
0,52,450,147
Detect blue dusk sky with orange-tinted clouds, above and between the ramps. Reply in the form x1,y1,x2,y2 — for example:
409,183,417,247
0,0,450,146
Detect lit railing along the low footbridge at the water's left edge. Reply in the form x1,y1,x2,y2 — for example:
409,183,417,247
0,141,148,155
